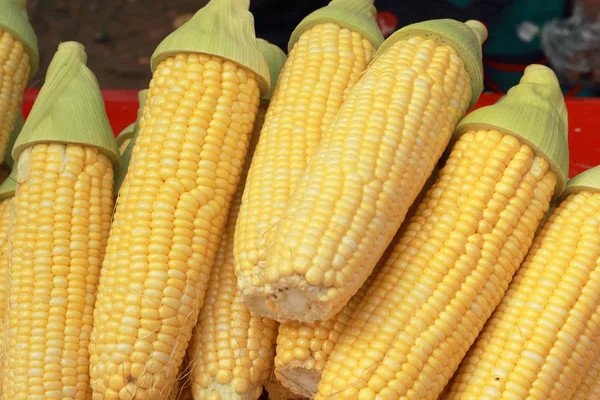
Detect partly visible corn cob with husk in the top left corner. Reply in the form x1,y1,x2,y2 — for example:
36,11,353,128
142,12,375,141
0,0,39,164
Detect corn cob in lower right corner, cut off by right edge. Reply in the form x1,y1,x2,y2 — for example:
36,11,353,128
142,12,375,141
444,163,600,400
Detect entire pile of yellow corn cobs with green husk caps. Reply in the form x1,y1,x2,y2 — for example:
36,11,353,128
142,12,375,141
0,0,600,400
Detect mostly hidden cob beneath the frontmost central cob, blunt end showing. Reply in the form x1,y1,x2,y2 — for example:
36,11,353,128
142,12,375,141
275,168,439,399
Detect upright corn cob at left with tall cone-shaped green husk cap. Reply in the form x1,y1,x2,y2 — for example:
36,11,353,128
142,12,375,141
2,42,119,400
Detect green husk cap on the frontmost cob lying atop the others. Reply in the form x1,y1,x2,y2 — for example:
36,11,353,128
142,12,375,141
375,19,487,108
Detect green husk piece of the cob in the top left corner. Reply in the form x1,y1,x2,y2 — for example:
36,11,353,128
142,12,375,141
0,0,40,78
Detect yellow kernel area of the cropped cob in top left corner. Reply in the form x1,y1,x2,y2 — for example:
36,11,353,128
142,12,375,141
0,27,31,164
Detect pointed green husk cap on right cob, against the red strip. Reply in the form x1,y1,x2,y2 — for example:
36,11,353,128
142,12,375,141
455,64,569,196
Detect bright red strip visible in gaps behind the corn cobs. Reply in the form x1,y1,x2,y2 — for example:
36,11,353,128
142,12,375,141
23,89,600,176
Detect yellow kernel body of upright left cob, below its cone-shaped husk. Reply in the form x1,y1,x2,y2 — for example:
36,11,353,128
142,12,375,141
2,143,113,400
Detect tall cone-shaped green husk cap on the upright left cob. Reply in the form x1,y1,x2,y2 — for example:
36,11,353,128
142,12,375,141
12,42,121,165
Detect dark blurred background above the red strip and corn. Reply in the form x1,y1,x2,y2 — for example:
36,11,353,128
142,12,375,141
28,0,600,96
